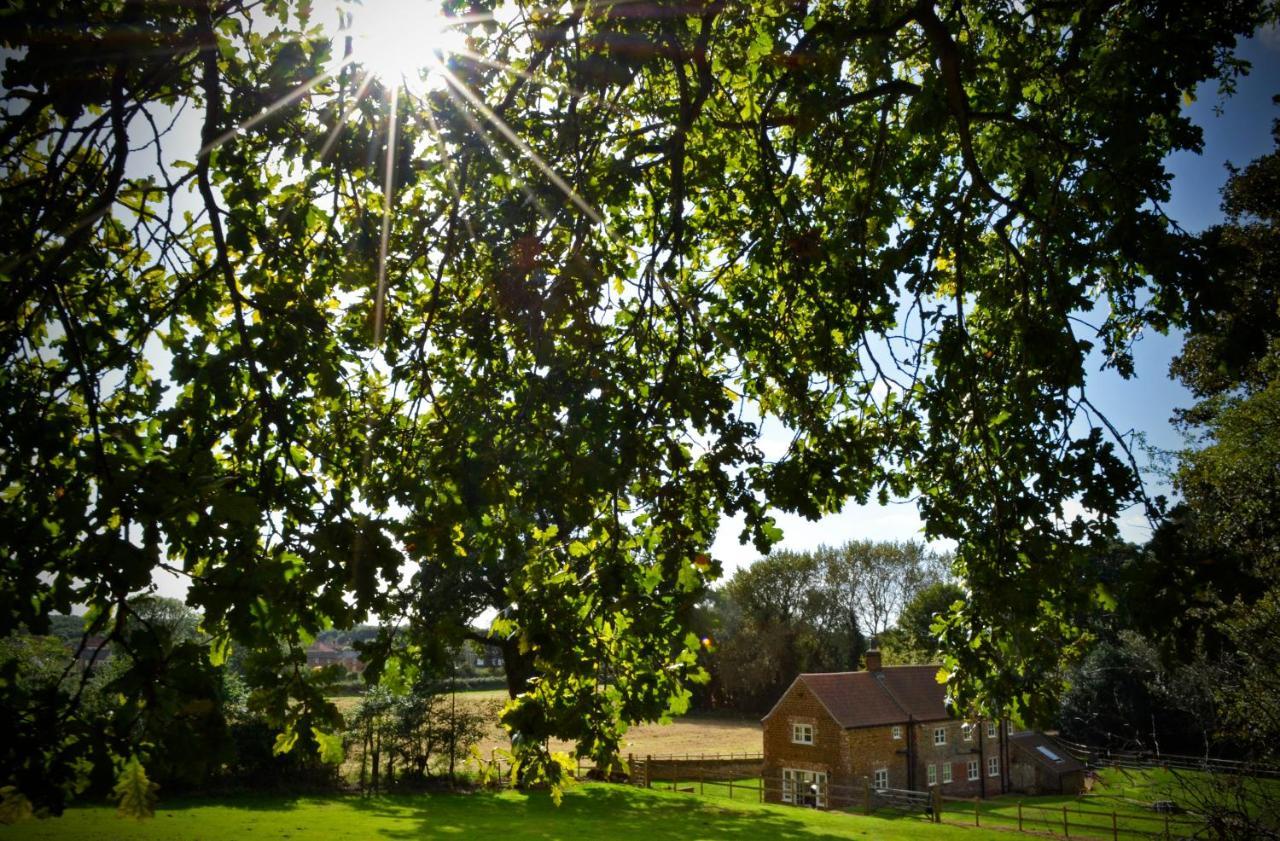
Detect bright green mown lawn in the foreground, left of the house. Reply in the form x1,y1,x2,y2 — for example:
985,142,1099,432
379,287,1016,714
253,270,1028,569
0,783,980,841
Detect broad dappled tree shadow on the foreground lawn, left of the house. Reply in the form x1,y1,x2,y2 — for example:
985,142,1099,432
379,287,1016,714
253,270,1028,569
352,785,870,841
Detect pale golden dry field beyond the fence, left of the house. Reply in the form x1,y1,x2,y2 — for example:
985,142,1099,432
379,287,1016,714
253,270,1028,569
333,690,763,757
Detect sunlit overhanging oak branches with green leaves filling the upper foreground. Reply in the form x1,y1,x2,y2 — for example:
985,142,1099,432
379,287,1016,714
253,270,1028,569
0,0,1275,808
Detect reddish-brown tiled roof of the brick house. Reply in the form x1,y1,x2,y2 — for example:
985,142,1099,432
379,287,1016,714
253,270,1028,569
797,666,951,730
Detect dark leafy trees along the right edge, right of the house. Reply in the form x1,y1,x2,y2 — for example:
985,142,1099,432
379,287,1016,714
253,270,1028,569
1062,127,1280,783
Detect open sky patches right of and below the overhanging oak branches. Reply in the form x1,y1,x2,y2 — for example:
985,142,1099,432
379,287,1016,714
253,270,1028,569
712,28,1280,575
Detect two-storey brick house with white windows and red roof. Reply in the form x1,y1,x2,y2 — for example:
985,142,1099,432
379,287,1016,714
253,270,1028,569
763,650,1010,808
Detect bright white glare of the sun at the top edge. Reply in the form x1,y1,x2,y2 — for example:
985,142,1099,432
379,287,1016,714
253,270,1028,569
339,0,465,91
